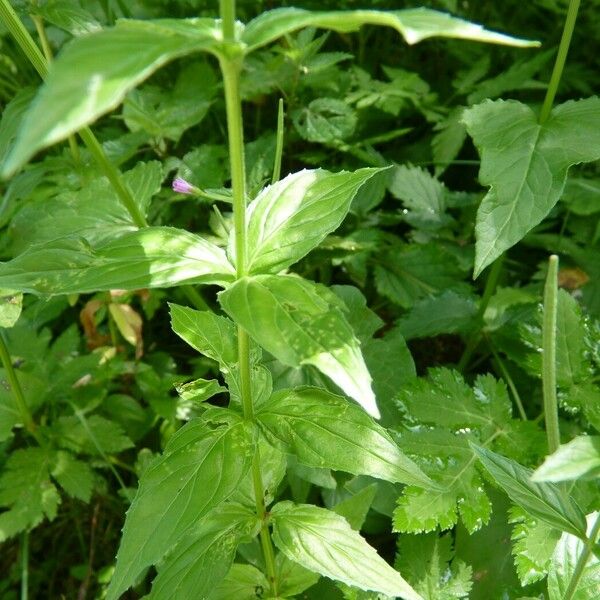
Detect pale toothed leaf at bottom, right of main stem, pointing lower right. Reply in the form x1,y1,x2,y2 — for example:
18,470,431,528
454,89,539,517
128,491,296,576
271,501,423,600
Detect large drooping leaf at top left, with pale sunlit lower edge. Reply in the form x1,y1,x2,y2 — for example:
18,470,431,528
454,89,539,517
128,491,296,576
3,19,219,177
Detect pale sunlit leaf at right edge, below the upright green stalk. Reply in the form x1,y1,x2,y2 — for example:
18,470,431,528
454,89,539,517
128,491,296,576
532,436,600,481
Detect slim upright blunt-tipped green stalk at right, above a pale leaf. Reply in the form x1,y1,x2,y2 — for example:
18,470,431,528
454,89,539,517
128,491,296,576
542,254,560,454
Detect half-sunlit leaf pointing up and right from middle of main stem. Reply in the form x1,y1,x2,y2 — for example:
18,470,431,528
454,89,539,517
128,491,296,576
234,169,379,274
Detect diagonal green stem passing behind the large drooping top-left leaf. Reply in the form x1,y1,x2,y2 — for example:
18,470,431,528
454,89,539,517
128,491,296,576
0,0,148,227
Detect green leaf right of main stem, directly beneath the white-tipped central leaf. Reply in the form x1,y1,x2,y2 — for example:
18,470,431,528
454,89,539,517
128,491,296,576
257,387,433,487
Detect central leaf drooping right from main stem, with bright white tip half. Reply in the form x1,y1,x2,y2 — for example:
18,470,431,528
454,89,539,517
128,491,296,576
219,275,379,418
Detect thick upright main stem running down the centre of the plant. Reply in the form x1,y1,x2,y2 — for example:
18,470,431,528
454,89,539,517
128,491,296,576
219,0,277,596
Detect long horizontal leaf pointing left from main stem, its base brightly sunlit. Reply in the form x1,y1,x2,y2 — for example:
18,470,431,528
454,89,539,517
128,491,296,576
0,227,235,294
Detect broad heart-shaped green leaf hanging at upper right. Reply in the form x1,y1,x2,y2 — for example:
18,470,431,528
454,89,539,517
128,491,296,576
463,98,600,277
